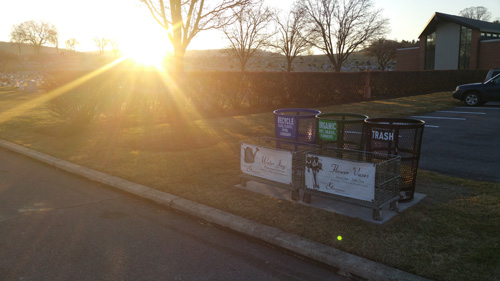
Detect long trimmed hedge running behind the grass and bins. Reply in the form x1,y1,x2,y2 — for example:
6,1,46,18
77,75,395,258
43,69,487,119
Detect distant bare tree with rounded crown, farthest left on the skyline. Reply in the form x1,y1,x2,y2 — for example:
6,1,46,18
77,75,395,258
11,20,58,53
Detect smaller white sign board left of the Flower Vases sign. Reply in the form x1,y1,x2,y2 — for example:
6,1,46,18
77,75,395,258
240,143,292,184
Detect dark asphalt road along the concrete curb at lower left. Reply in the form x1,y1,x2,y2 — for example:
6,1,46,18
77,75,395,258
0,149,345,280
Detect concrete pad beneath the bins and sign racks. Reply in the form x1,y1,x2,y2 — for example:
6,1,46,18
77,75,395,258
235,181,426,224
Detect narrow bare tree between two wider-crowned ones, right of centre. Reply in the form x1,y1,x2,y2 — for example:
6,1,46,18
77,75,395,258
273,2,311,72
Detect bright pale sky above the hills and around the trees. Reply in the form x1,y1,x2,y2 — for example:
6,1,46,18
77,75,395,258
0,0,500,51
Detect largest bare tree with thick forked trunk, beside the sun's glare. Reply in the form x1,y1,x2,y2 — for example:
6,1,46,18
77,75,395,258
141,0,251,72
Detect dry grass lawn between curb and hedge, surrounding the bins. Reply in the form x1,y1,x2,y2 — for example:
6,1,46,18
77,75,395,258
0,88,500,280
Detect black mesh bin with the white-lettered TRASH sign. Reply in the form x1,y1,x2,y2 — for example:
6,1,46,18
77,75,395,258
364,118,425,202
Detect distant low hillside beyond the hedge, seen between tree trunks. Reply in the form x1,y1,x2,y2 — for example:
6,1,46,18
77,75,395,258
0,41,388,72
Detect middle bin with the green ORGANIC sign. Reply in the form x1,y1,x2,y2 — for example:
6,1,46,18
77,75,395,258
316,113,368,150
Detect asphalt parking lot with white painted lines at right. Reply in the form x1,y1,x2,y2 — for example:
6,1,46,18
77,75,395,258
411,102,500,182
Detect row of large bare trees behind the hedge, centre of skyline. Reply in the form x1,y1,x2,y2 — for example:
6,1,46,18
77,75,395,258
141,0,389,72
